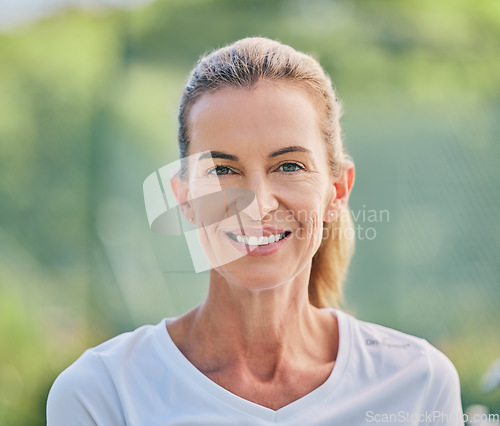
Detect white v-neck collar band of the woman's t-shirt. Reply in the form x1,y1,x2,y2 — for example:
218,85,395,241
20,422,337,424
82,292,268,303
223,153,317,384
152,308,351,423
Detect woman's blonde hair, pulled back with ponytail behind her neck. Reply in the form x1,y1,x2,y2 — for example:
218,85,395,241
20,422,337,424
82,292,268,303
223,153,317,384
178,37,354,307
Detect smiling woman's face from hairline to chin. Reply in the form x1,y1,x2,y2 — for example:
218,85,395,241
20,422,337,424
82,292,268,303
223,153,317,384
179,82,339,289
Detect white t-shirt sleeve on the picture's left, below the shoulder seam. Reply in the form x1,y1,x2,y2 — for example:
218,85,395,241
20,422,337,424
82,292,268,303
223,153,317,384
47,351,125,426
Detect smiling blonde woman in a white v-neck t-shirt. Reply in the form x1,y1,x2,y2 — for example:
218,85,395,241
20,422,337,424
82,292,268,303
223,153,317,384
48,38,463,426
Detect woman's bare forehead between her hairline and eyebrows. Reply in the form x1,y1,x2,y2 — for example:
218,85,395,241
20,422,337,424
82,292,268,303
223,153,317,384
189,82,322,154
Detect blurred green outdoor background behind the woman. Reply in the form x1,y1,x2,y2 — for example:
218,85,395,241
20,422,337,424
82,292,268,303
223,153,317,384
0,0,500,426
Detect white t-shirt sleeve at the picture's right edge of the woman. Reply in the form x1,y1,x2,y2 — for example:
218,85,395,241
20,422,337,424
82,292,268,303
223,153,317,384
425,344,464,426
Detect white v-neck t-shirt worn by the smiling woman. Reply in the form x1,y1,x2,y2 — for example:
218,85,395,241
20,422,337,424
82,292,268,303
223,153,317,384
47,309,464,426
